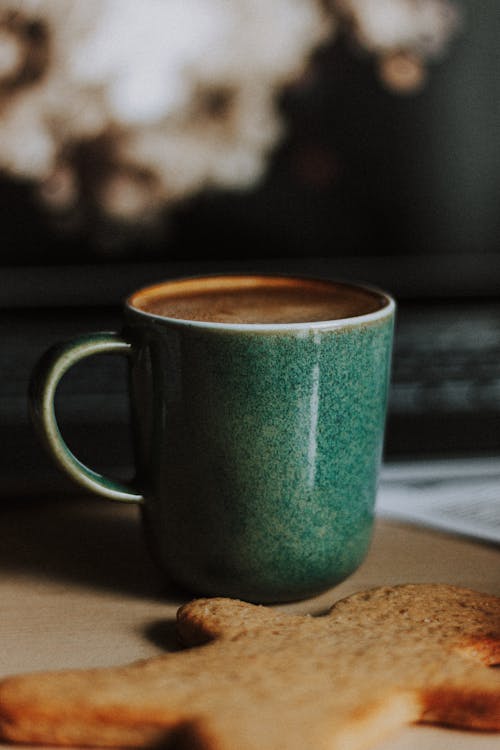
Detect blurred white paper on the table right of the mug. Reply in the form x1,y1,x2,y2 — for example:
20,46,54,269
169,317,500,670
377,459,500,544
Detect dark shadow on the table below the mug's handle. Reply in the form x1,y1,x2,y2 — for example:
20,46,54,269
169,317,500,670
0,498,190,603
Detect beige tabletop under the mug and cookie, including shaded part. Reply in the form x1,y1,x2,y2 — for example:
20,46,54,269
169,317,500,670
0,498,500,750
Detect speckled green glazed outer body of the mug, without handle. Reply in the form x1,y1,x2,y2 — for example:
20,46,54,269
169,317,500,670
126,280,393,602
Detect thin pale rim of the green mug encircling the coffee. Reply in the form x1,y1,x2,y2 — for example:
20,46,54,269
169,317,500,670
125,272,396,332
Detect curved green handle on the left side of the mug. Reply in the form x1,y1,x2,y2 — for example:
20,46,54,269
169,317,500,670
29,333,143,503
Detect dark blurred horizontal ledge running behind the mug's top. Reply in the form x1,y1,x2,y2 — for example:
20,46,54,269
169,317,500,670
0,253,500,310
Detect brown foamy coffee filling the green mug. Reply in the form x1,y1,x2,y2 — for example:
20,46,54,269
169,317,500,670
130,276,387,324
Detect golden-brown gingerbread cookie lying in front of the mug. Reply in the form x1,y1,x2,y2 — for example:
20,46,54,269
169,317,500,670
0,584,500,750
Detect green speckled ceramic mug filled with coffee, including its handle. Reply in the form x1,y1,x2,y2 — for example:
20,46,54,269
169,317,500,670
31,275,395,602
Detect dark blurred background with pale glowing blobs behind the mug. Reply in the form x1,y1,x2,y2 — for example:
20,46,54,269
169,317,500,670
0,0,500,496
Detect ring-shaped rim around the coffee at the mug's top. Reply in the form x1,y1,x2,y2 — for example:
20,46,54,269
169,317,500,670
125,273,396,332
